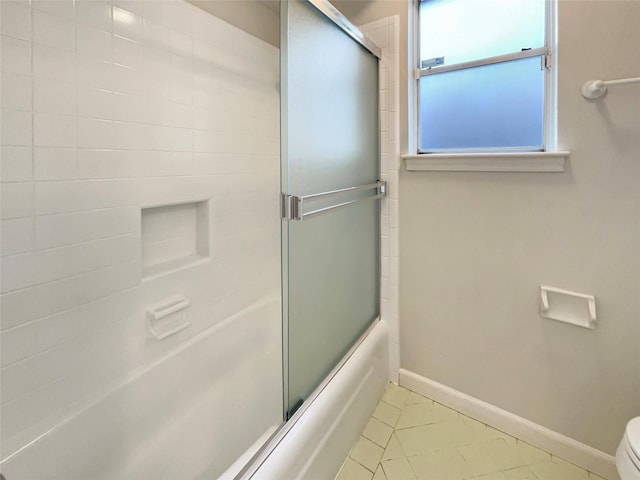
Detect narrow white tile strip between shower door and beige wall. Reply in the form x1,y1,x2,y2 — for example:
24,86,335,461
360,16,400,382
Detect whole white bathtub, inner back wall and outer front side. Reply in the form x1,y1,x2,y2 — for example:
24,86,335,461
1,298,389,480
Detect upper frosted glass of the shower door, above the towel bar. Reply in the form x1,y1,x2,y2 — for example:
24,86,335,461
283,0,378,195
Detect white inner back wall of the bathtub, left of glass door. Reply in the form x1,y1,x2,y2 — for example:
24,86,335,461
1,297,282,480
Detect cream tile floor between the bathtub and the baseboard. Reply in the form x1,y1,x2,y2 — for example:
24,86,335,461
336,383,604,480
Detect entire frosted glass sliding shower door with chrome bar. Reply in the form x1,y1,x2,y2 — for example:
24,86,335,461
281,0,384,417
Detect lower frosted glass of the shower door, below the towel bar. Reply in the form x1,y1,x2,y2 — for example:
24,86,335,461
289,201,379,407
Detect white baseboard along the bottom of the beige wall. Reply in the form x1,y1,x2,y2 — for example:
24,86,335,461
400,368,619,480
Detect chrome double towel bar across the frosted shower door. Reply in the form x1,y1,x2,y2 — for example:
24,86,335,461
282,182,387,222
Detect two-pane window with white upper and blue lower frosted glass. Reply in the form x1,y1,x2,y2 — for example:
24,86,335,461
416,0,550,153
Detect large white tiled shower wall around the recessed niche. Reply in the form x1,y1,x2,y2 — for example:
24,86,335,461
0,0,280,457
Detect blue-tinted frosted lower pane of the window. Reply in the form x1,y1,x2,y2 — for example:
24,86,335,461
419,57,544,151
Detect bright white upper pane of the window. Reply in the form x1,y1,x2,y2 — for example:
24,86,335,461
420,0,545,68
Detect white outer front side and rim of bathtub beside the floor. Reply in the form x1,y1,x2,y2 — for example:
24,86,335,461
249,320,390,480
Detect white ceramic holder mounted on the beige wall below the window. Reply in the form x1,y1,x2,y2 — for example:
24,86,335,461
540,285,596,329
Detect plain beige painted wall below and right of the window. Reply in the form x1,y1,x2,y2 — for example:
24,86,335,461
400,0,640,453
